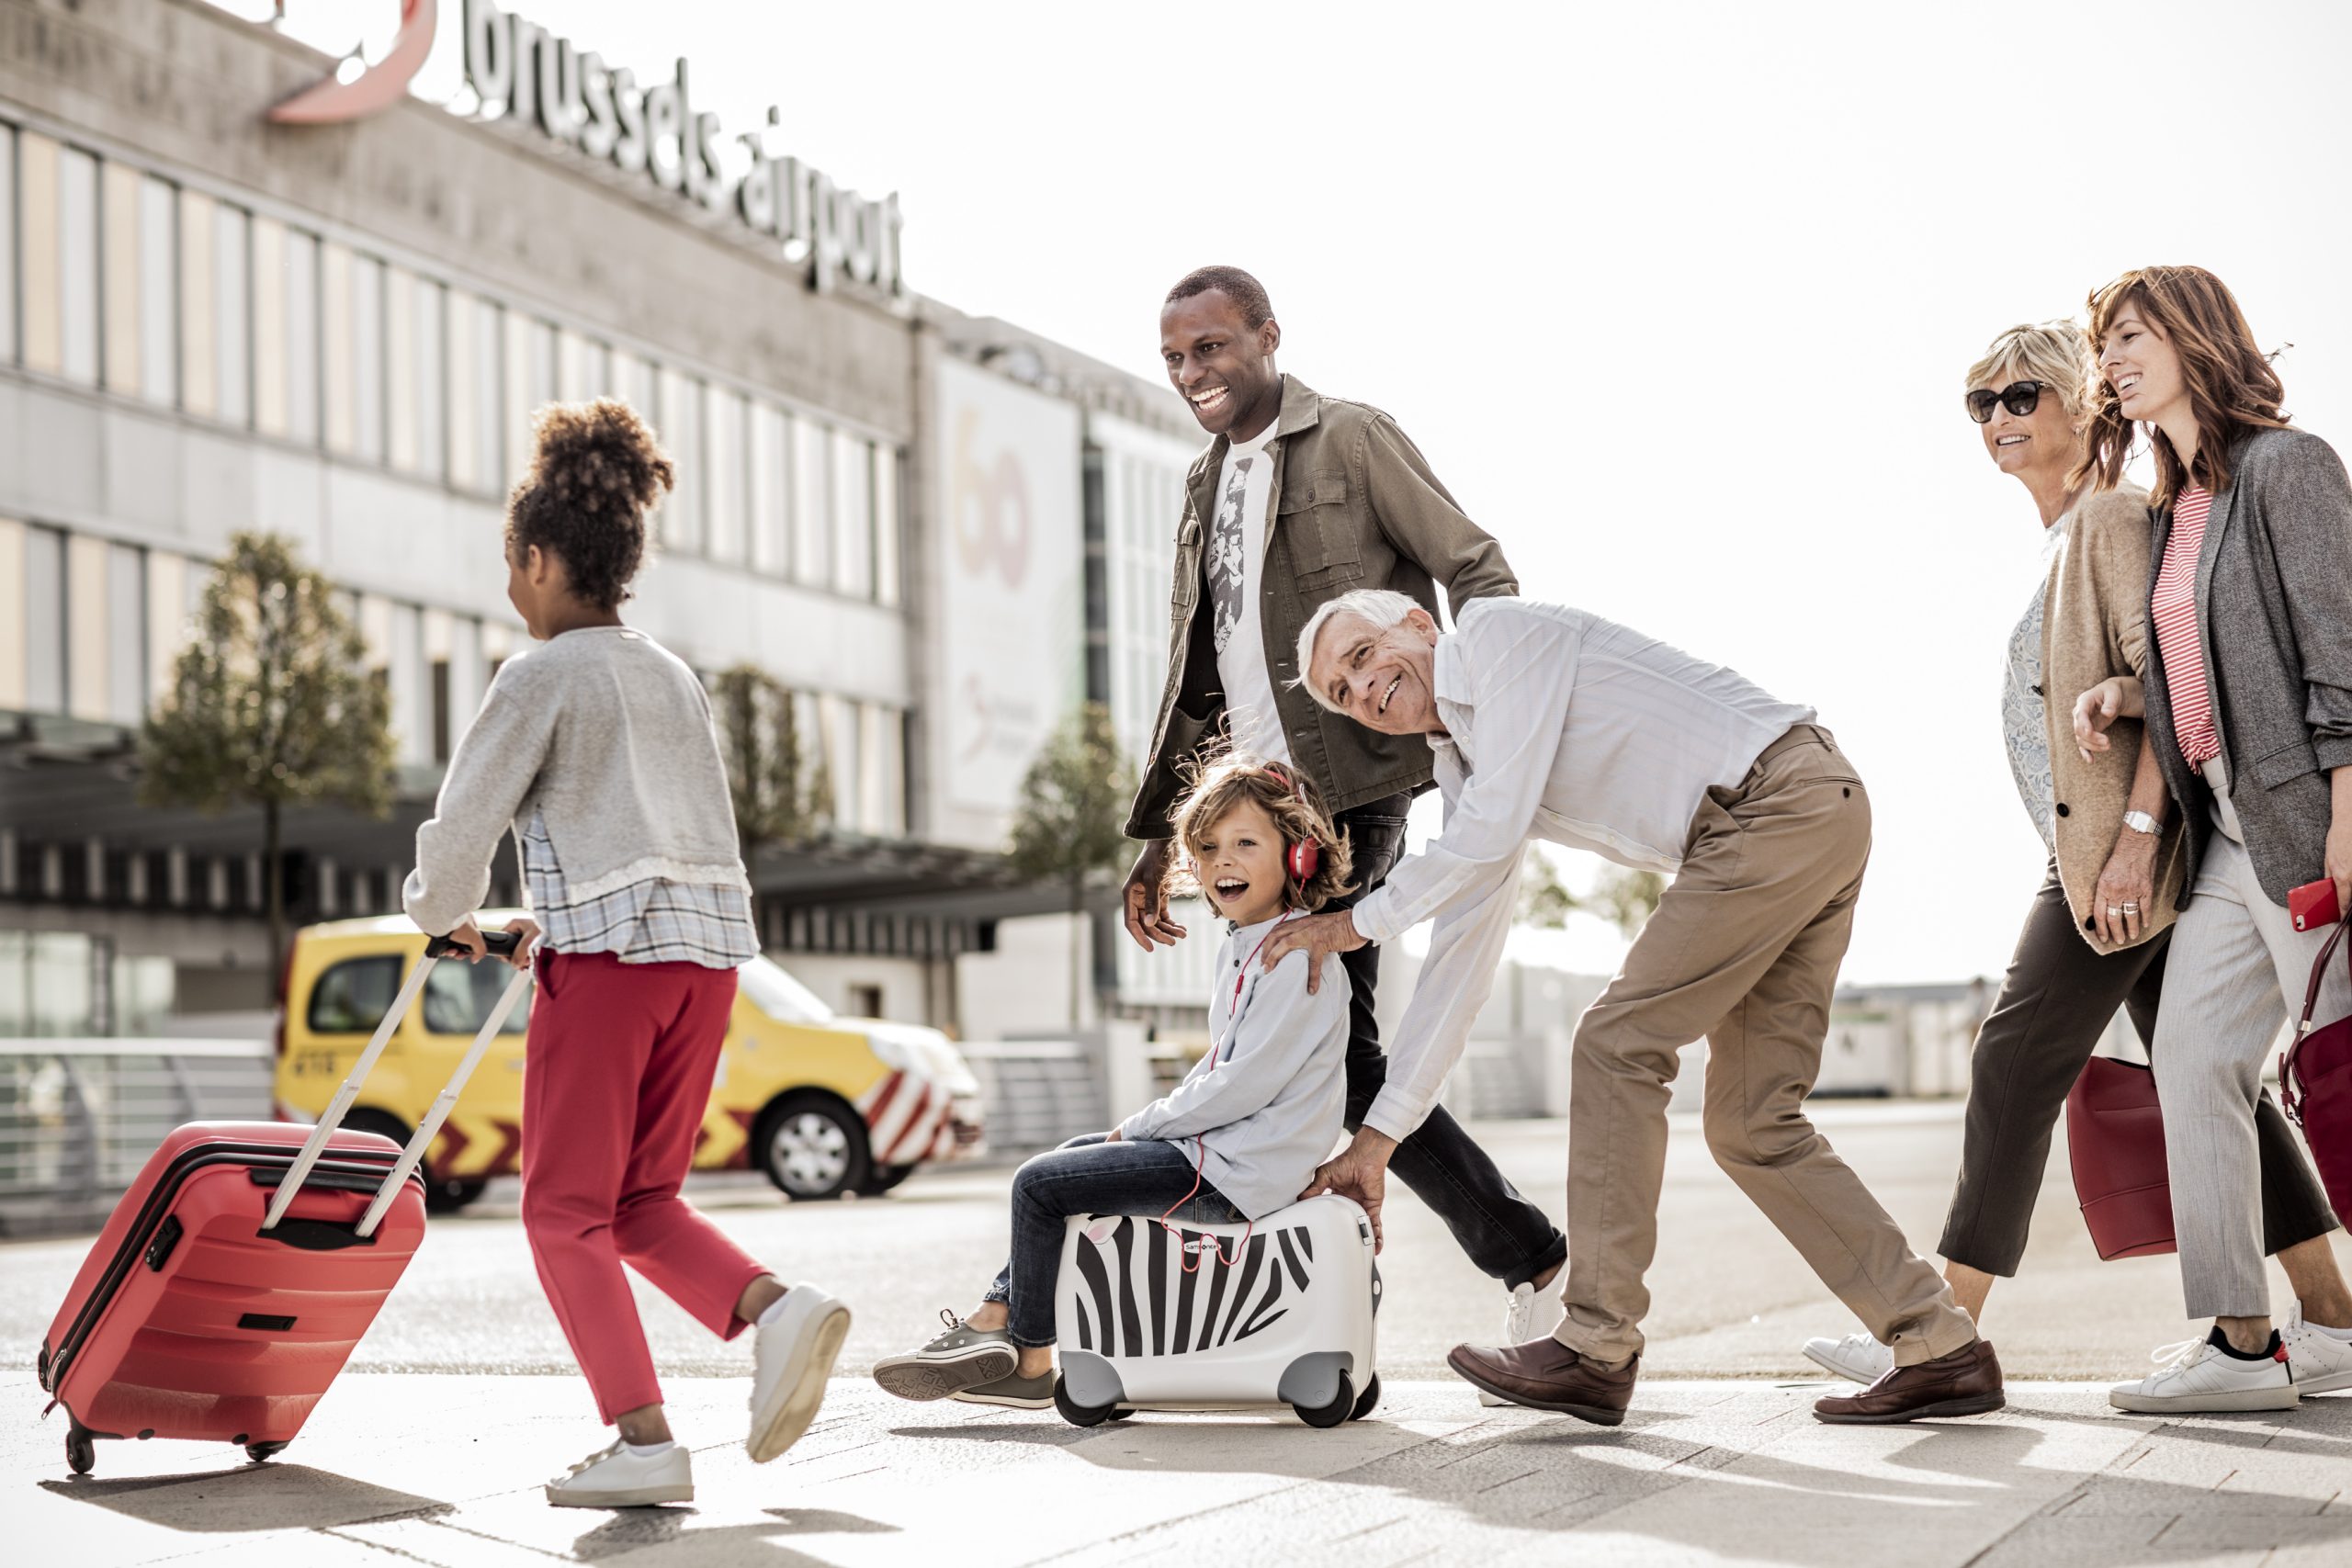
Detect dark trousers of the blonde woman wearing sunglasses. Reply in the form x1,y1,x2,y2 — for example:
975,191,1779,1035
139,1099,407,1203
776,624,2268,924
1940,863,2335,1279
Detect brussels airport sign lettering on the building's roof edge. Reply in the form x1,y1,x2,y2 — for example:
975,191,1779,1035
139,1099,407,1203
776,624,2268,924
466,0,906,299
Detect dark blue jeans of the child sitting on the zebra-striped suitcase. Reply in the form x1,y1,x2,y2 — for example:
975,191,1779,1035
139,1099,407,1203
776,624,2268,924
981,1134,1242,1349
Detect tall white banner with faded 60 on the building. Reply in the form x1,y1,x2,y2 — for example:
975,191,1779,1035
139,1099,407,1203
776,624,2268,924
932,357,1084,849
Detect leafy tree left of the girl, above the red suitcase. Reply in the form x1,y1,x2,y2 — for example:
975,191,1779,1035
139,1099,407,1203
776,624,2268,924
139,534,393,976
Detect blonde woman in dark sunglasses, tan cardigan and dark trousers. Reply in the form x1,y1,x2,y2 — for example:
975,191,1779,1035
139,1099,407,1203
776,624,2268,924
1804,322,2352,1382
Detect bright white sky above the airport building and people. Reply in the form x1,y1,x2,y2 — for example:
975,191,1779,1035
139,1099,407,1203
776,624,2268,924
231,0,2352,983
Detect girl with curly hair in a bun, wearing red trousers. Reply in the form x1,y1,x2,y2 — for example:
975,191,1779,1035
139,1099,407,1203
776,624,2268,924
404,400,849,1506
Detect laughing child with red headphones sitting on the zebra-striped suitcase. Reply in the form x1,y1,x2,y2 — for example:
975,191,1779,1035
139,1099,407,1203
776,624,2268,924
875,757,1350,1411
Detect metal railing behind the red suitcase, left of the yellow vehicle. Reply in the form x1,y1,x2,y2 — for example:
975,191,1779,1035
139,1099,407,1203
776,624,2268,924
0,1039,276,1236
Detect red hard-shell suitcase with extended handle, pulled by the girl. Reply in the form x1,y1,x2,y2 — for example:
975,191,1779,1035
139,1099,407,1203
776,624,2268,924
40,933,526,1474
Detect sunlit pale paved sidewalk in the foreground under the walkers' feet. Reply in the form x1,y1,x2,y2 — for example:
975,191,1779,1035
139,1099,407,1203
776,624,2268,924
18,1373,2352,1568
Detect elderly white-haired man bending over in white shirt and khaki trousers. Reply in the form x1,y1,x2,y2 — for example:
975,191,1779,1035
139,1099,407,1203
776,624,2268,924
1265,590,2002,1427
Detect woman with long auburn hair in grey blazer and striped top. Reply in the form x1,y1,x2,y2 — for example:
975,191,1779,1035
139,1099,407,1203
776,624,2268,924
2072,265,2352,1413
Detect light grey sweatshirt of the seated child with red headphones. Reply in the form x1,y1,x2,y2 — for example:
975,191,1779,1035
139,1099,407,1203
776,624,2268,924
1120,919,1350,1220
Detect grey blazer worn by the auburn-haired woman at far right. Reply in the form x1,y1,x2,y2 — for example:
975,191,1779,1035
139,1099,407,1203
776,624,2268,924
2147,430,2352,905
